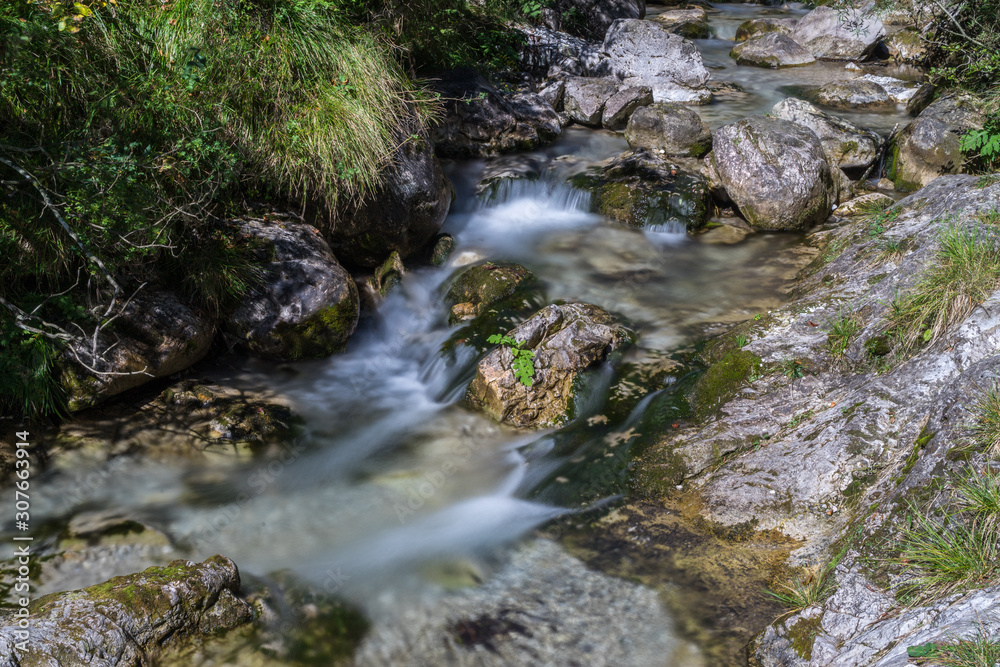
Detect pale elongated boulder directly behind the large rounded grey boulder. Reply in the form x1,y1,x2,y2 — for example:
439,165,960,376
771,97,882,169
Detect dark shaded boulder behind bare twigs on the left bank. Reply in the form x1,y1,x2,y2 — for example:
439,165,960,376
59,289,215,411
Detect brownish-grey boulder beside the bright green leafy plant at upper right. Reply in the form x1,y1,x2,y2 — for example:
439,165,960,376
886,94,983,192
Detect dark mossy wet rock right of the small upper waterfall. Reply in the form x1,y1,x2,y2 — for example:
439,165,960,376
573,150,710,231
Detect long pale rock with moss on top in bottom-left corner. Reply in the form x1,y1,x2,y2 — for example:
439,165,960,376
0,556,254,667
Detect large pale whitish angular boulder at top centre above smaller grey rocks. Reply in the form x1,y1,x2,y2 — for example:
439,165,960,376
602,20,712,104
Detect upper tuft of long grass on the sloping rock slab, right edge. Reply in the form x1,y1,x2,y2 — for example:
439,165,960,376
885,225,1000,356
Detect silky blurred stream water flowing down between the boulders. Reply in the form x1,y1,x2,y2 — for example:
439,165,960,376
0,4,920,664
